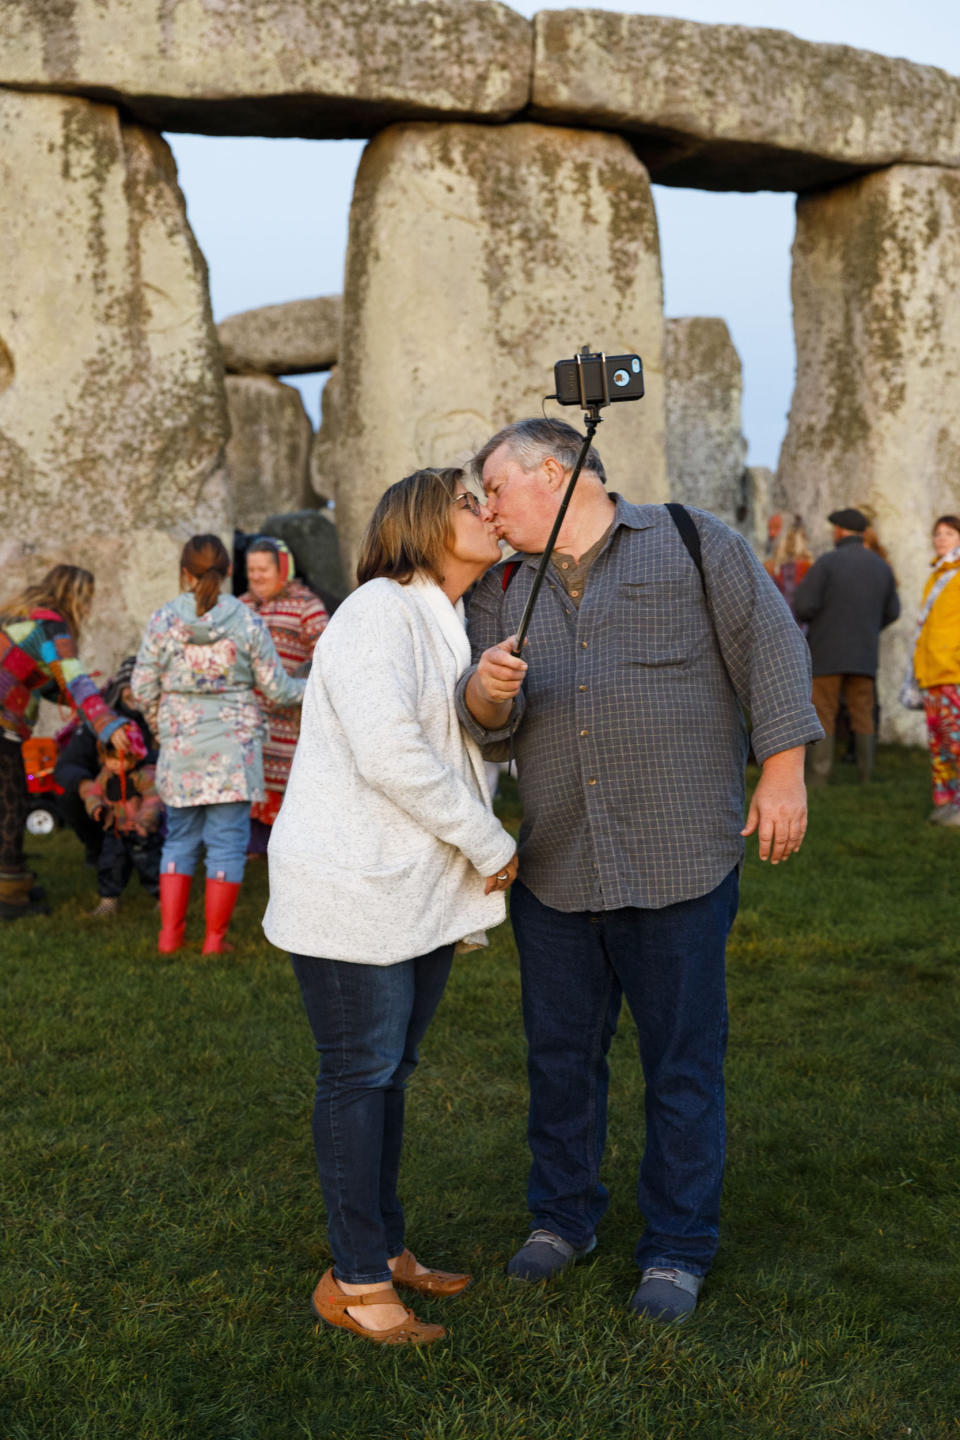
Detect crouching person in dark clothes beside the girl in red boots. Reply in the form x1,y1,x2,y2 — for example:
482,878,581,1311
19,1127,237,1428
79,726,163,920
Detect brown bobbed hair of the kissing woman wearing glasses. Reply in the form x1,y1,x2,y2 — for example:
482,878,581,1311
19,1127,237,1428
357,468,465,585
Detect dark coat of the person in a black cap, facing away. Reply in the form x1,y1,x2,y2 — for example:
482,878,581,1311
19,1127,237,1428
793,536,900,675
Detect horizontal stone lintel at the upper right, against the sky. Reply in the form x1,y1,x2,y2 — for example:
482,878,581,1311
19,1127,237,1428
531,10,960,190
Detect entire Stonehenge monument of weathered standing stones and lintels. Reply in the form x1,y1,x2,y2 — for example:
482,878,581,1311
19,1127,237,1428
0,0,960,742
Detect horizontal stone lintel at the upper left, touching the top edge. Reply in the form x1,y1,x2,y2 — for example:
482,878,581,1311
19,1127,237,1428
0,0,533,140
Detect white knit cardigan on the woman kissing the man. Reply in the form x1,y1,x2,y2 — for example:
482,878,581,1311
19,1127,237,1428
263,579,515,965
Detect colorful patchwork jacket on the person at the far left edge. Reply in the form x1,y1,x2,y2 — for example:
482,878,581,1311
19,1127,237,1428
0,609,125,740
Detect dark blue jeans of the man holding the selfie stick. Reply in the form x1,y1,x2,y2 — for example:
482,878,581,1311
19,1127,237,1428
511,870,738,1274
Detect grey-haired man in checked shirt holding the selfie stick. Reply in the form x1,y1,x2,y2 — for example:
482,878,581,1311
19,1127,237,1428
458,420,820,1320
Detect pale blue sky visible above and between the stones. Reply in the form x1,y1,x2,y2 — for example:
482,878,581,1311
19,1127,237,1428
167,0,960,467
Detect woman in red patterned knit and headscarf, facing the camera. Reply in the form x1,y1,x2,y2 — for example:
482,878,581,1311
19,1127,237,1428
240,536,330,855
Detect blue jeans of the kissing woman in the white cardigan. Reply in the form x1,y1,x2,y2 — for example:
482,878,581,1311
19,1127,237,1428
291,945,453,1284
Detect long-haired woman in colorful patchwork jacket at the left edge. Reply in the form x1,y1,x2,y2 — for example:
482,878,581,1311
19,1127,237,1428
0,564,128,920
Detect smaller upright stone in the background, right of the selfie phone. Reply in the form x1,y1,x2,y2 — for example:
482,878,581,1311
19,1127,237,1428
664,317,751,534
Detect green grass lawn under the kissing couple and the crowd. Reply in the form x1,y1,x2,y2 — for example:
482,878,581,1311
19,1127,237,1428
0,750,960,1440
